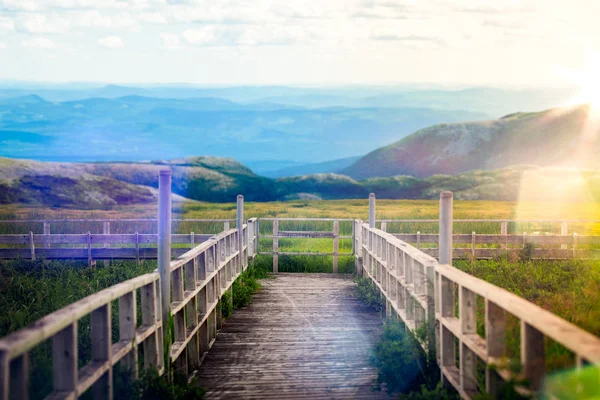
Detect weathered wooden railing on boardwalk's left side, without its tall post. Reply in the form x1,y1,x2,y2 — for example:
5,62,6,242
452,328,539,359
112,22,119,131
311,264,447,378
0,219,257,400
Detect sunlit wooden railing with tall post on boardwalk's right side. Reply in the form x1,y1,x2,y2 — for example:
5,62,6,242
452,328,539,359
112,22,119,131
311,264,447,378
355,192,600,399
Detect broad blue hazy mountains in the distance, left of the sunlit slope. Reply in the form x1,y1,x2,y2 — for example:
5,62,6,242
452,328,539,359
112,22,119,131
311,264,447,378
0,94,484,163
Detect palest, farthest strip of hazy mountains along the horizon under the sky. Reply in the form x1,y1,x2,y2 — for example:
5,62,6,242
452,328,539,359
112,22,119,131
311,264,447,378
0,82,578,117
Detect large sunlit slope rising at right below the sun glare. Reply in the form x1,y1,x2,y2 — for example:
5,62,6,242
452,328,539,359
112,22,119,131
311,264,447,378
341,105,600,179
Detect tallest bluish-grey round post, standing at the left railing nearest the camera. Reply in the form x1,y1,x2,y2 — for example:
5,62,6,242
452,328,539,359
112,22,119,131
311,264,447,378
158,170,171,327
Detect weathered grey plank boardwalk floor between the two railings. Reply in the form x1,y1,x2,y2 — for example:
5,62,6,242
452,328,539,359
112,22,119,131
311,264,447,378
197,274,391,399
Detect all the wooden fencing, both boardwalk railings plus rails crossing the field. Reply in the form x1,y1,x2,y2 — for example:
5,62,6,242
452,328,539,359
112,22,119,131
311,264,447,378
0,188,600,400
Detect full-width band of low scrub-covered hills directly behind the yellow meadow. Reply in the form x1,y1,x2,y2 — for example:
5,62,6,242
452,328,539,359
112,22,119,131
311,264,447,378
0,157,600,209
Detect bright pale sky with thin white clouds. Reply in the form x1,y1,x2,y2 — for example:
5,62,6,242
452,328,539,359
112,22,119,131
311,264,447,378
0,0,600,86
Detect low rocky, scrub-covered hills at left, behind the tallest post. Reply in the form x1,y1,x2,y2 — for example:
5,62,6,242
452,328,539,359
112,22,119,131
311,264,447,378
0,157,275,208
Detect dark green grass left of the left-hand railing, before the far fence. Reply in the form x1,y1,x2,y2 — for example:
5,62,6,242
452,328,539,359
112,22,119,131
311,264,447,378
0,260,156,398
